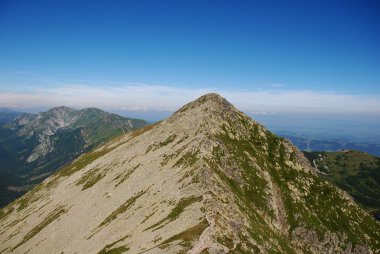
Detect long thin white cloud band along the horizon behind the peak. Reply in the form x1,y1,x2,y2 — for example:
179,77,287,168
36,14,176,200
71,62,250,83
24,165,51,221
0,84,380,115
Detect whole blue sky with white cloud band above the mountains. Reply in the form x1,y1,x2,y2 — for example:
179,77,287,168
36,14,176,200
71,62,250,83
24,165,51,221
0,0,380,117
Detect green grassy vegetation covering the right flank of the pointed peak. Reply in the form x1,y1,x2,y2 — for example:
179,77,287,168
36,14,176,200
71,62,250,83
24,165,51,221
206,116,380,253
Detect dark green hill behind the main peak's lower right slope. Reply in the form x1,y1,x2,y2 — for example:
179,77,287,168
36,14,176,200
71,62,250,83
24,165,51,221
304,150,380,220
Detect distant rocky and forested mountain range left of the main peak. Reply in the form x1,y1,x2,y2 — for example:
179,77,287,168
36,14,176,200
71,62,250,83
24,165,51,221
0,107,147,207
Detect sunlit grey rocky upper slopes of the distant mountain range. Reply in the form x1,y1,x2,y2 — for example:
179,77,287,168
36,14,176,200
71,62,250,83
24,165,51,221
11,106,147,163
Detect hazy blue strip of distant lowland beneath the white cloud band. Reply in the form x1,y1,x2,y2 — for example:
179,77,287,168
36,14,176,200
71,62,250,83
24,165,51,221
1,101,380,144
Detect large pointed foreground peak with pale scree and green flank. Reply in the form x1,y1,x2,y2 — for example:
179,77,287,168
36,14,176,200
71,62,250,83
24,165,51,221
0,94,380,254
